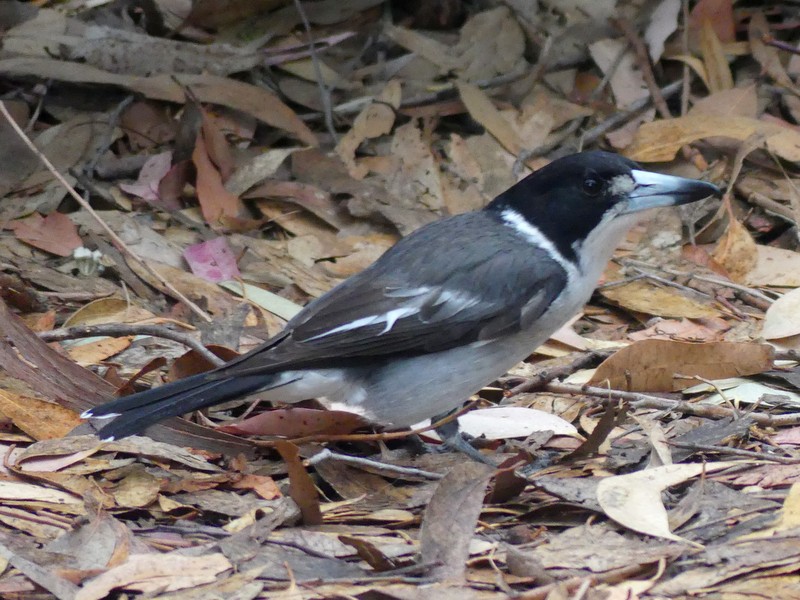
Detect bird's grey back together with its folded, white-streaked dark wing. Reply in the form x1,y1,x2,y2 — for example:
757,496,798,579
214,213,567,377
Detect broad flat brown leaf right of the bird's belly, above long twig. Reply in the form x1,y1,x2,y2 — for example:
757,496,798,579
590,340,772,392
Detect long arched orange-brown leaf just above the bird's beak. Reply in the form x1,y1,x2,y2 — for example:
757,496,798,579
625,115,800,162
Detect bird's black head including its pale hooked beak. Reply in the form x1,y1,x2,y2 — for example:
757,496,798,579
486,151,720,262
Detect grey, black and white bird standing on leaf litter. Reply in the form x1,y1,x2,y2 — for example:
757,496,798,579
81,150,721,462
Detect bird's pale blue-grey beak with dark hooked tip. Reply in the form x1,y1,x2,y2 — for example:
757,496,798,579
625,169,722,213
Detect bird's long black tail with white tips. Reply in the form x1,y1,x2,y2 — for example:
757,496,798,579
81,373,272,441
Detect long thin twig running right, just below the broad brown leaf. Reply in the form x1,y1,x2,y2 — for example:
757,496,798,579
545,383,800,427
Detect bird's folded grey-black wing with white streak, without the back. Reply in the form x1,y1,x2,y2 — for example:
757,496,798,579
217,247,566,374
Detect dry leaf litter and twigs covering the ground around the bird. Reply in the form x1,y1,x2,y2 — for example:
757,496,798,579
0,0,800,600
